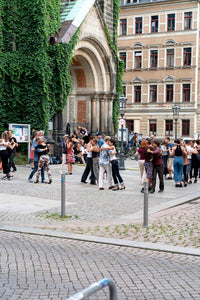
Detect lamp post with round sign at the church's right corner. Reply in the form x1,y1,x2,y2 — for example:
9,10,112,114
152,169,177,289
118,94,127,170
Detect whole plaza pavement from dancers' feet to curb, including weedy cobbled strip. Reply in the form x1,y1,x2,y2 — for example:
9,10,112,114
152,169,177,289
0,160,200,253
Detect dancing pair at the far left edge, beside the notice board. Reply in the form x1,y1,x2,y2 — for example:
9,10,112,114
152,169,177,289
0,130,18,180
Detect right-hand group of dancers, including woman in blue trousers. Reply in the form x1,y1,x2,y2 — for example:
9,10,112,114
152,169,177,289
135,137,200,193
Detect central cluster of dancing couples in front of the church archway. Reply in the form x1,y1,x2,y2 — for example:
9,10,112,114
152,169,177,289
60,127,125,191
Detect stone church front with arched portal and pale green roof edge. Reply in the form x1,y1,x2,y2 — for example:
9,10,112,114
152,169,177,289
52,0,116,142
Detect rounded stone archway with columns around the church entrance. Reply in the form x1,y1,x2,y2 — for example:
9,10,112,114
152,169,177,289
67,38,115,134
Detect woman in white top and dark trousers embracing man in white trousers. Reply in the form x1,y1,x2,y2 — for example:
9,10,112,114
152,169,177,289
108,139,125,191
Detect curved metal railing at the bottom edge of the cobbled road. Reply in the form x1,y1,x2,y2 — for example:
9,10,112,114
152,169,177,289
66,278,118,300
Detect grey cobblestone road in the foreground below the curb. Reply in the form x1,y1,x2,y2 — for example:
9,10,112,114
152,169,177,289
0,231,200,300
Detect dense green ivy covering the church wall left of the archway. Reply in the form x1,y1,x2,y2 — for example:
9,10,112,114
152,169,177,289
0,0,78,131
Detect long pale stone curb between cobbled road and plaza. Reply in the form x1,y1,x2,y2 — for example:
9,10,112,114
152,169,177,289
0,225,200,256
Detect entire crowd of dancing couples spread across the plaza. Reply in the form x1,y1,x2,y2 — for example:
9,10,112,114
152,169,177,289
0,127,200,193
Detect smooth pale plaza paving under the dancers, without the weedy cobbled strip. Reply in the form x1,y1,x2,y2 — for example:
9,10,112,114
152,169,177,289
0,161,199,226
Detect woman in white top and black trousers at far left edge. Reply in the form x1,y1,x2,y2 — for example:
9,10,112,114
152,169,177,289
0,131,13,180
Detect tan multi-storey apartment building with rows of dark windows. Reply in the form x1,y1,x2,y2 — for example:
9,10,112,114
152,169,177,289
118,0,200,139
